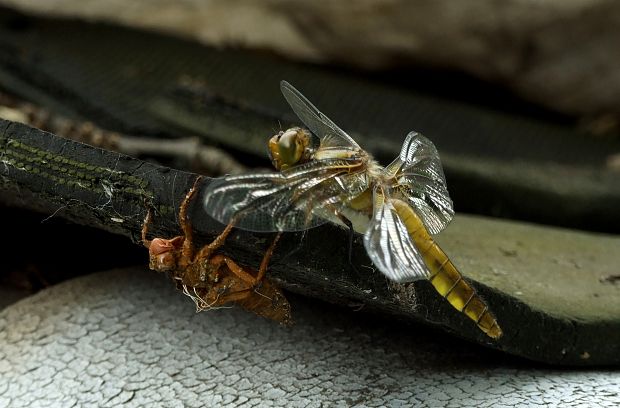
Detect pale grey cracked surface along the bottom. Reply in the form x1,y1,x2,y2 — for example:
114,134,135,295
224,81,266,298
0,268,620,407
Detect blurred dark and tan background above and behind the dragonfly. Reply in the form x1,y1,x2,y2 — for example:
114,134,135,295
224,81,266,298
0,0,620,290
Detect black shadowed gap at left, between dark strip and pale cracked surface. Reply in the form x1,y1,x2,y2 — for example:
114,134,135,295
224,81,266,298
0,206,143,295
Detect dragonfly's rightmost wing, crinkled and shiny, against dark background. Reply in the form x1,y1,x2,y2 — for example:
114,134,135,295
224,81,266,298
386,132,454,234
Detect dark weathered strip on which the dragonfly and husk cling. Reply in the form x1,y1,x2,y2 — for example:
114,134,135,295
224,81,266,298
0,121,620,365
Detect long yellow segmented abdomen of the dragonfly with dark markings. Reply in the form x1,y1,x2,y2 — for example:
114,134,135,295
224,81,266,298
392,200,502,339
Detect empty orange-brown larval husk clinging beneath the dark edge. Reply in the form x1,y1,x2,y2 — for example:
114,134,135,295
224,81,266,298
142,177,292,326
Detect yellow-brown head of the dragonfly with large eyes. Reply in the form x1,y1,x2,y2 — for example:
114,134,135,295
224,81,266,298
269,127,312,170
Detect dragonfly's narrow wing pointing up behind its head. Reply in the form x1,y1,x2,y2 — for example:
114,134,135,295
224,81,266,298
280,81,359,149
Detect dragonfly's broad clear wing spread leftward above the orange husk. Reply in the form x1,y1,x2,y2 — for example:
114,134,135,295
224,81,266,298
204,159,359,232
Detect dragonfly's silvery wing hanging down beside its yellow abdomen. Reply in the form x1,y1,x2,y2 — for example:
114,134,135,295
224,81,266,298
364,196,430,282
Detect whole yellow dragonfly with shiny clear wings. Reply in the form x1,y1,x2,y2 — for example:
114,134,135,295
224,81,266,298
204,81,502,339
